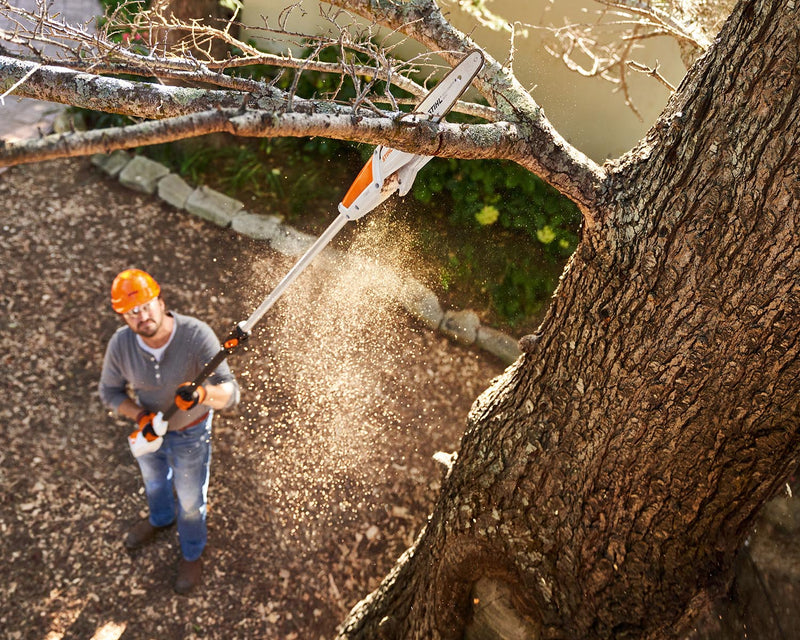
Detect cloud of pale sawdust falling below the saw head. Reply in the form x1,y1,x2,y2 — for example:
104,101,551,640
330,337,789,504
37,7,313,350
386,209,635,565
234,210,440,542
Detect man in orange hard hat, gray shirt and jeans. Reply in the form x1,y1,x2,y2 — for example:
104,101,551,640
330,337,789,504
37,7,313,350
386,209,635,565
99,269,239,594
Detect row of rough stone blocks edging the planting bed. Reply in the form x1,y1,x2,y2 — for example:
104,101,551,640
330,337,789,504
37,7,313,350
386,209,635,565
91,151,521,365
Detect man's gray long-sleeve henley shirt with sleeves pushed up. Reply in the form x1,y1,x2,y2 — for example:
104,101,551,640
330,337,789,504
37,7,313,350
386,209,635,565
99,312,239,431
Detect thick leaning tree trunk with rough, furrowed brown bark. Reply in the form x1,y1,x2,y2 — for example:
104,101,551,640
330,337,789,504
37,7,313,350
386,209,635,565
341,0,800,639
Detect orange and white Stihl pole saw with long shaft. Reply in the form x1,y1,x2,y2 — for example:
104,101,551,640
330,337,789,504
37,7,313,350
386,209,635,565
130,50,483,455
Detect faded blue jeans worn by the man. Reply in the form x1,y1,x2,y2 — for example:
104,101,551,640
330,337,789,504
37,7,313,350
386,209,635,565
137,411,214,561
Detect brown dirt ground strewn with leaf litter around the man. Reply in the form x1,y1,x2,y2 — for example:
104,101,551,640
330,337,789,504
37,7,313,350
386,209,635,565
0,160,502,640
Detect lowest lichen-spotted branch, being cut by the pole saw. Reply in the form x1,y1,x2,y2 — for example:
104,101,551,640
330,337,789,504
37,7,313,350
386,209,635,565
0,109,604,226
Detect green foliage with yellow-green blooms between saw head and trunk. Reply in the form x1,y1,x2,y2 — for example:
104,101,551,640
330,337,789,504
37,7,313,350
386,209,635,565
412,158,580,329
